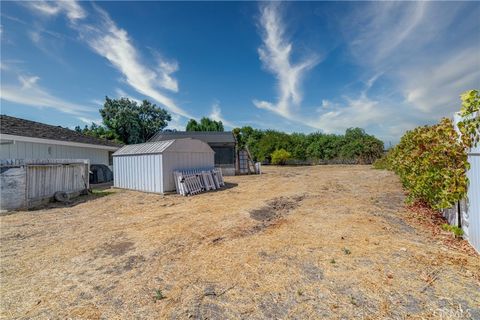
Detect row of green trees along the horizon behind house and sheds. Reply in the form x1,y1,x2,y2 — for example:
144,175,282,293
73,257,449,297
75,97,383,164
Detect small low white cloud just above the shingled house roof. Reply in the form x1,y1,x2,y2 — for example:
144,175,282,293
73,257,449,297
0,75,93,117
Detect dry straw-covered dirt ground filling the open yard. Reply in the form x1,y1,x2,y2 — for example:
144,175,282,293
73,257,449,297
0,166,480,319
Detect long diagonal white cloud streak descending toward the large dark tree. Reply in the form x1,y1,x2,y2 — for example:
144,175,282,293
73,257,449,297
22,1,191,118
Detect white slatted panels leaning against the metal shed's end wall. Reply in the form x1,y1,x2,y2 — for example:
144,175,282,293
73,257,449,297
173,168,225,196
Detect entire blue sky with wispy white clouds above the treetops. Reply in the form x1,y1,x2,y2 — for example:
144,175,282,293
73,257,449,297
0,1,480,143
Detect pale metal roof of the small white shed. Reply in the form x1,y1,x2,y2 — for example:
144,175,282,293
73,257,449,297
113,138,214,157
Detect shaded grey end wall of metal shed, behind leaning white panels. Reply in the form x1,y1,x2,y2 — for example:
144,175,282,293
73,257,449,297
163,152,215,192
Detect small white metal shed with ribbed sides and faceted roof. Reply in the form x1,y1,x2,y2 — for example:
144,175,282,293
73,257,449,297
113,138,215,193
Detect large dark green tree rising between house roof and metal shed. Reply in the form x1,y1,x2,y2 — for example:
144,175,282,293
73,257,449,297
100,97,172,144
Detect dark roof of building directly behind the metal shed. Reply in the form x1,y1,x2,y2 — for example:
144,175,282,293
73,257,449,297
148,131,235,143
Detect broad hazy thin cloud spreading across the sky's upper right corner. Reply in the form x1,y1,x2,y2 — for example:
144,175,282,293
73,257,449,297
343,1,480,116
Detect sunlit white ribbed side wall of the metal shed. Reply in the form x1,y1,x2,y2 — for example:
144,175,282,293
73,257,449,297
113,154,164,193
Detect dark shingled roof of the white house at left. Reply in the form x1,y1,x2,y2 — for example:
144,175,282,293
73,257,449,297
0,114,121,147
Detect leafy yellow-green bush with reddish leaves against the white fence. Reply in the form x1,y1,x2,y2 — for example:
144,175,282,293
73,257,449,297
375,90,480,209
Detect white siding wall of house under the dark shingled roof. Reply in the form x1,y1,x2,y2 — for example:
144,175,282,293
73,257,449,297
0,141,108,166
